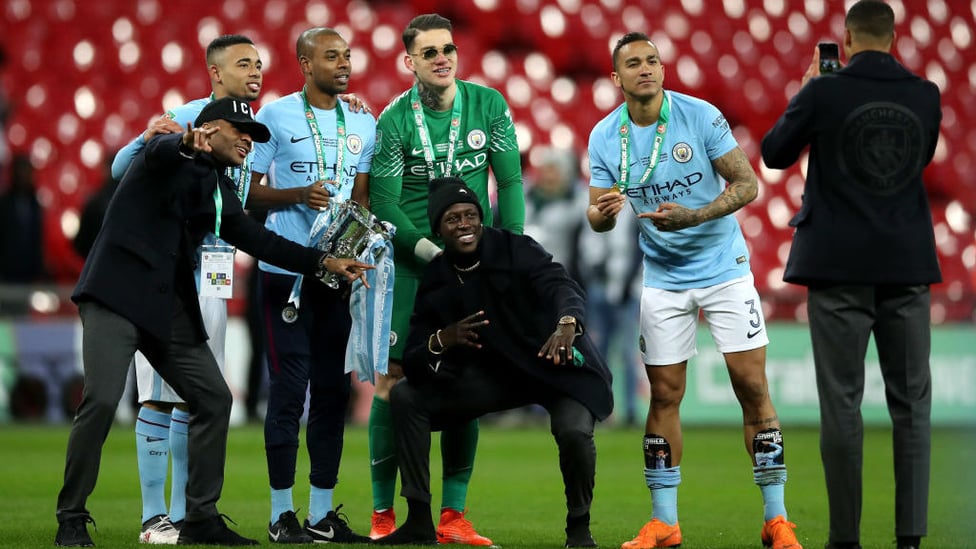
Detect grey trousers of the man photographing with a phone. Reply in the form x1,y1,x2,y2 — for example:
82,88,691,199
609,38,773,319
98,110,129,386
807,285,932,543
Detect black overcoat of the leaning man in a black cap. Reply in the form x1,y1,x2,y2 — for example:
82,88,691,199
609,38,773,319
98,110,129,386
72,134,322,343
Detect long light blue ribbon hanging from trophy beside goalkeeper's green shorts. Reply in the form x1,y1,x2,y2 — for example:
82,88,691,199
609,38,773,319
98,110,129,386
346,234,396,383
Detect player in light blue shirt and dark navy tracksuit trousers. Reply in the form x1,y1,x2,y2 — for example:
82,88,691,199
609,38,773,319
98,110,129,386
250,28,376,543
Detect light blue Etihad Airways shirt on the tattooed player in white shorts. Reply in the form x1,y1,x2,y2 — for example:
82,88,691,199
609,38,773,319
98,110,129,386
589,91,749,290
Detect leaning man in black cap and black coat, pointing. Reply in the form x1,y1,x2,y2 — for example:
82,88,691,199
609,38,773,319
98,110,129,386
55,97,370,546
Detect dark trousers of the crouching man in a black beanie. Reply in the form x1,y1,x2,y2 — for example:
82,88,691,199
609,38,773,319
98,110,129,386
390,364,596,516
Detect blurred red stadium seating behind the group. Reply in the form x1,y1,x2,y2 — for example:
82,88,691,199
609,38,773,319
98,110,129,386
0,0,976,424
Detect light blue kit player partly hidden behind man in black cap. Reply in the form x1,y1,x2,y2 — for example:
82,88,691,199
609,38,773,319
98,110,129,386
112,34,262,545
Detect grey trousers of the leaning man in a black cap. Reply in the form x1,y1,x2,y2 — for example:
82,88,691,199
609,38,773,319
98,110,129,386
57,299,232,522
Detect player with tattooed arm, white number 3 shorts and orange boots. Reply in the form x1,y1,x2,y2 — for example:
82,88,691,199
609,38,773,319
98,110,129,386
587,33,801,549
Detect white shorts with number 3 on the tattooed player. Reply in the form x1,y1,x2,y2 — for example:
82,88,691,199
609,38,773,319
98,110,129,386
640,273,769,366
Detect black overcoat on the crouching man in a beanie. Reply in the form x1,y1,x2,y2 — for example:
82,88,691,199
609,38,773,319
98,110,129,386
404,227,613,420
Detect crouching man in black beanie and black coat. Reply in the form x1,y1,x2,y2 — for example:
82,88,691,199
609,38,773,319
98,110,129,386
376,177,613,547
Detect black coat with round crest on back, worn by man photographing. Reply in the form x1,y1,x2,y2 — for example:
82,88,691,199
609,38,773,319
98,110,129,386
762,51,942,285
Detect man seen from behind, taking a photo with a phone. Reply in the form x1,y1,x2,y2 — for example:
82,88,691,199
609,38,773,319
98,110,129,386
762,4,942,548
